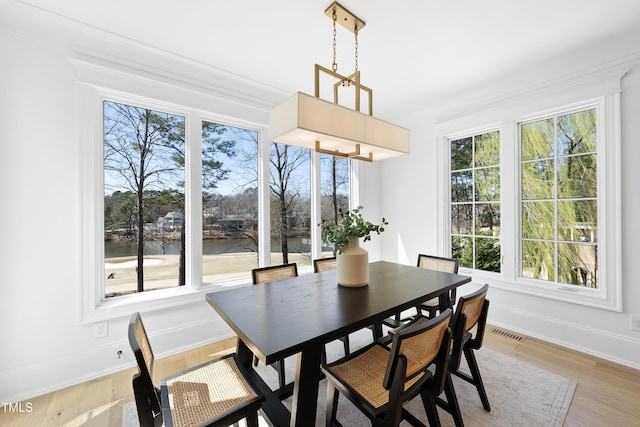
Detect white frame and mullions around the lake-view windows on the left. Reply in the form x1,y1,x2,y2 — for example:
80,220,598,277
78,58,357,324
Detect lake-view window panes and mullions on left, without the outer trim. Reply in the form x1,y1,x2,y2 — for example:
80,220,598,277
96,95,349,300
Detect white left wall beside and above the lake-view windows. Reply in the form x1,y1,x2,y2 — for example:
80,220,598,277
0,3,382,402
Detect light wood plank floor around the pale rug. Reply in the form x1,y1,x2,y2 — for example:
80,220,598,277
0,326,640,427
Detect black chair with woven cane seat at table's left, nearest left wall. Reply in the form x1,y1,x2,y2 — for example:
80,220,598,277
129,313,265,427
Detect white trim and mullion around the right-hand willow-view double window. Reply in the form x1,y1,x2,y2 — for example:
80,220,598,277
436,70,627,312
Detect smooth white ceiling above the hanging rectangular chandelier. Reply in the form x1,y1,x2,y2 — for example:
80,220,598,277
0,0,640,119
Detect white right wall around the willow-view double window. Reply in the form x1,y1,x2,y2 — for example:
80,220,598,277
381,40,640,368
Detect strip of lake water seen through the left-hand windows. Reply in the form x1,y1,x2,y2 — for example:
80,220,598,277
104,237,311,258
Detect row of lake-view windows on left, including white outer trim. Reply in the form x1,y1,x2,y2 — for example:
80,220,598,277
78,58,357,323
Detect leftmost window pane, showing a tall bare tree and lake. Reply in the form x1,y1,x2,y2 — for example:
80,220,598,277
103,101,186,297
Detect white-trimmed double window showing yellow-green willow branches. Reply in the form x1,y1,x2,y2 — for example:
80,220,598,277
436,70,625,311
